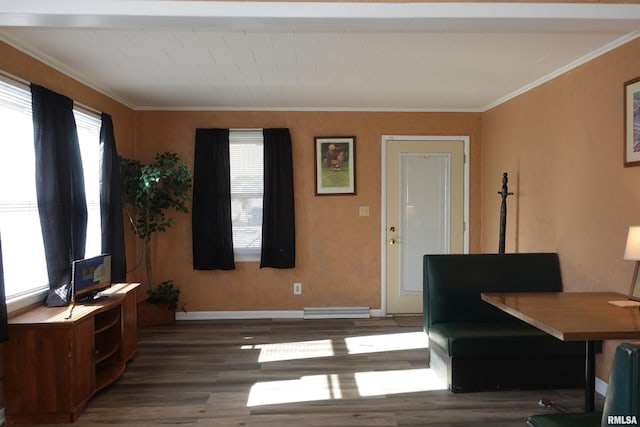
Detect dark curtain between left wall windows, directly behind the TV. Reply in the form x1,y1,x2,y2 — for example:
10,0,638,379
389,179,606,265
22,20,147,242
31,84,87,289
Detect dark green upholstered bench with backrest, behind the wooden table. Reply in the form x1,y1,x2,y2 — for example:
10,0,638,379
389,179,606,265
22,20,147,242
423,253,585,393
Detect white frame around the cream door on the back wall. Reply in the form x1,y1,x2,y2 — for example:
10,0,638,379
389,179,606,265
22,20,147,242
380,135,470,316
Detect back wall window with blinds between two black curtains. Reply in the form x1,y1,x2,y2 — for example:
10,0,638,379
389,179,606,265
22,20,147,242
229,130,264,261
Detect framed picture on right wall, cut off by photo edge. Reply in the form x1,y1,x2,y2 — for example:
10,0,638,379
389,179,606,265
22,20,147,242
624,77,640,167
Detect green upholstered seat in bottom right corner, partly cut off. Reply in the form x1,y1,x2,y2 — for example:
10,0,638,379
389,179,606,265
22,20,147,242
527,343,640,427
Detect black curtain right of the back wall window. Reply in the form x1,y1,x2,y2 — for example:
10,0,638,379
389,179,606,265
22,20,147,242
260,129,296,268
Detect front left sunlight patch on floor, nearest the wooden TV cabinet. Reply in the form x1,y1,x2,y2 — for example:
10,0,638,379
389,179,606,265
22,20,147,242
247,374,342,406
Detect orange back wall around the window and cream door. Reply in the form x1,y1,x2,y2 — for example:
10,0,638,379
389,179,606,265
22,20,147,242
136,111,481,312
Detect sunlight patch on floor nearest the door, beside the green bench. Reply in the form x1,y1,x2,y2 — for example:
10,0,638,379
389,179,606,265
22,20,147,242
344,331,429,354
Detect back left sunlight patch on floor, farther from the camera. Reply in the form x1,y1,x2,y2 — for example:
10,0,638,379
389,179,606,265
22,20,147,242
242,340,334,363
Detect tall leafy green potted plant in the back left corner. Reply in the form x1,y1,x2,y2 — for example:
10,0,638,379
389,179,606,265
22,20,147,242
120,152,192,324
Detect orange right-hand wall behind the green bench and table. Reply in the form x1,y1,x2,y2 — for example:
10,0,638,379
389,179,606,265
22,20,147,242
481,36,640,380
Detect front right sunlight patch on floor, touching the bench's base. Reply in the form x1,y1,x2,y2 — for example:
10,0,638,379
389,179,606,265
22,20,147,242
355,368,447,397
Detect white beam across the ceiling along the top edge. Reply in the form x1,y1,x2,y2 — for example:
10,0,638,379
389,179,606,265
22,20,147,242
0,0,640,32
